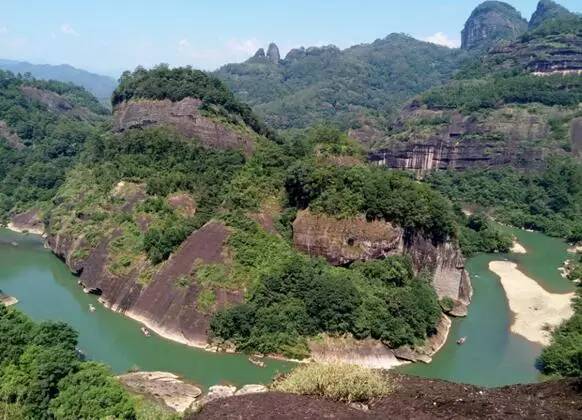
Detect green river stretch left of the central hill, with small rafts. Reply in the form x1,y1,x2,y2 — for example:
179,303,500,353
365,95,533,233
0,229,293,387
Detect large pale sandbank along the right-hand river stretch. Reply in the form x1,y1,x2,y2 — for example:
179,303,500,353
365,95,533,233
489,261,574,346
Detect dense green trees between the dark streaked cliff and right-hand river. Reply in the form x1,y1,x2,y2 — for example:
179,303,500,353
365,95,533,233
428,159,582,240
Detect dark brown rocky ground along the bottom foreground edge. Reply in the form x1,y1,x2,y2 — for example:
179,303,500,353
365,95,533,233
189,376,582,420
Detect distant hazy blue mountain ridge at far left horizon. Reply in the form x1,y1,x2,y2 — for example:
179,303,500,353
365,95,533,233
0,60,117,105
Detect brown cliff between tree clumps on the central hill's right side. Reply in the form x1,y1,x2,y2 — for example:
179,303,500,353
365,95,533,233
293,210,473,316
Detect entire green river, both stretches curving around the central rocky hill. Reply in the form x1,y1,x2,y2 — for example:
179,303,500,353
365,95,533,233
0,229,573,387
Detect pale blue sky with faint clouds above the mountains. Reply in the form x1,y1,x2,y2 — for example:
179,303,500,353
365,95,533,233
0,0,582,75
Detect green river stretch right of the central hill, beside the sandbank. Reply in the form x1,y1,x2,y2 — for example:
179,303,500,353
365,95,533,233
401,229,574,386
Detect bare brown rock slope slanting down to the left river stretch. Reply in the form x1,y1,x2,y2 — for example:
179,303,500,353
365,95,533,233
48,222,243,347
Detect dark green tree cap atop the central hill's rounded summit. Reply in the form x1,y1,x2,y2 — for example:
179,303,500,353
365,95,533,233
112,64,272,136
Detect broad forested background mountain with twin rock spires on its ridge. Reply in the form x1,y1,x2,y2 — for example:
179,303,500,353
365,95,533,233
215,34,465,133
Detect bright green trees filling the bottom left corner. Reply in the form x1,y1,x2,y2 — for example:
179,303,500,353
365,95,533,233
0,305,134,419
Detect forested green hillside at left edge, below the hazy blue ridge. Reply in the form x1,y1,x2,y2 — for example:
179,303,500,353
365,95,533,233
0,71,107,220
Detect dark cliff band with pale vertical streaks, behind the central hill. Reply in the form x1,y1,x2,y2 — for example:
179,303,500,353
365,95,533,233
368,104,550,176
